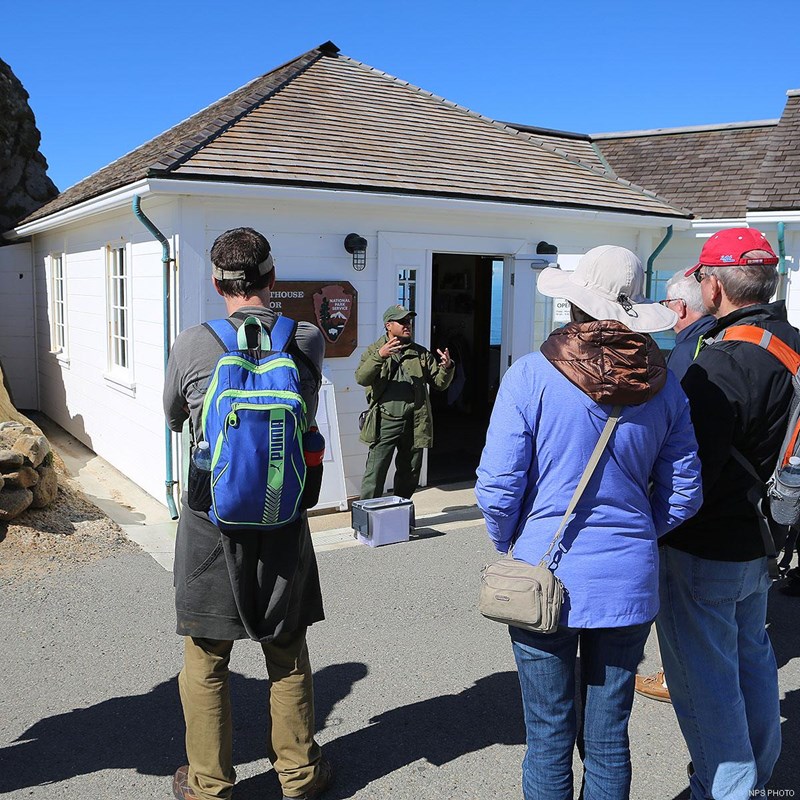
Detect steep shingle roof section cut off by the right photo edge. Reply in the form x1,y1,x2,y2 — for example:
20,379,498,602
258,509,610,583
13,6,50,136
747,89,800,211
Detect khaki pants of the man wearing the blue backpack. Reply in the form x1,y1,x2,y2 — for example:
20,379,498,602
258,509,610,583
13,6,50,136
178,628,321,800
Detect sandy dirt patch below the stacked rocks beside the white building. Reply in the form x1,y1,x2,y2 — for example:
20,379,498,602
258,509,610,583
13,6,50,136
0,451,138,586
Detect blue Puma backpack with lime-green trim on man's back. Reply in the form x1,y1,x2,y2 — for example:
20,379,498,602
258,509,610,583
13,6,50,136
202,316,307,532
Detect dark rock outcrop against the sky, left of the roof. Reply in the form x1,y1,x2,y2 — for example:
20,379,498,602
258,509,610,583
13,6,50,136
0,59,58,239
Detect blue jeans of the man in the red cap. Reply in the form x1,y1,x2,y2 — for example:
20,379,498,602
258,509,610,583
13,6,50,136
656,547,781,800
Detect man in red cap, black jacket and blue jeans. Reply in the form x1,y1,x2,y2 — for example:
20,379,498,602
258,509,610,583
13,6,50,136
657,228,800,800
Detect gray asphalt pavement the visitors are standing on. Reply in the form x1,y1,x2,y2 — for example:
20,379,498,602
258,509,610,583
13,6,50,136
0,516,800,800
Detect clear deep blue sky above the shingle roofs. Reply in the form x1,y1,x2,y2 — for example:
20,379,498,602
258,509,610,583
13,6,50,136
0,0,800,189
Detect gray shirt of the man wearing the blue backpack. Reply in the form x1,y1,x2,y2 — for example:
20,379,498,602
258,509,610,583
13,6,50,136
164,306,325,438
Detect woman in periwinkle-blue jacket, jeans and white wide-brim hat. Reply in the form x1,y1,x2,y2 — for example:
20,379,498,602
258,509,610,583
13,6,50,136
475,245,702,800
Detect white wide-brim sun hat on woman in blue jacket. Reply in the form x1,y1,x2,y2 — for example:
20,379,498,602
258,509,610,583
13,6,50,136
536,244,678,333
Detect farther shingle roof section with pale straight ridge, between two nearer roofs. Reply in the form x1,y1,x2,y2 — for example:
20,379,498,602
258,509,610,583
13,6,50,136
592,120,776,218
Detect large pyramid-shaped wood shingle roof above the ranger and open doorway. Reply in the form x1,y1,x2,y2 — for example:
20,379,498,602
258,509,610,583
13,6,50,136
20,42,688,224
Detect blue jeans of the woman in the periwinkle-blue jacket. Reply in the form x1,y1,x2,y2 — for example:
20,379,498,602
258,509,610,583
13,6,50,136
509,622,651,800
